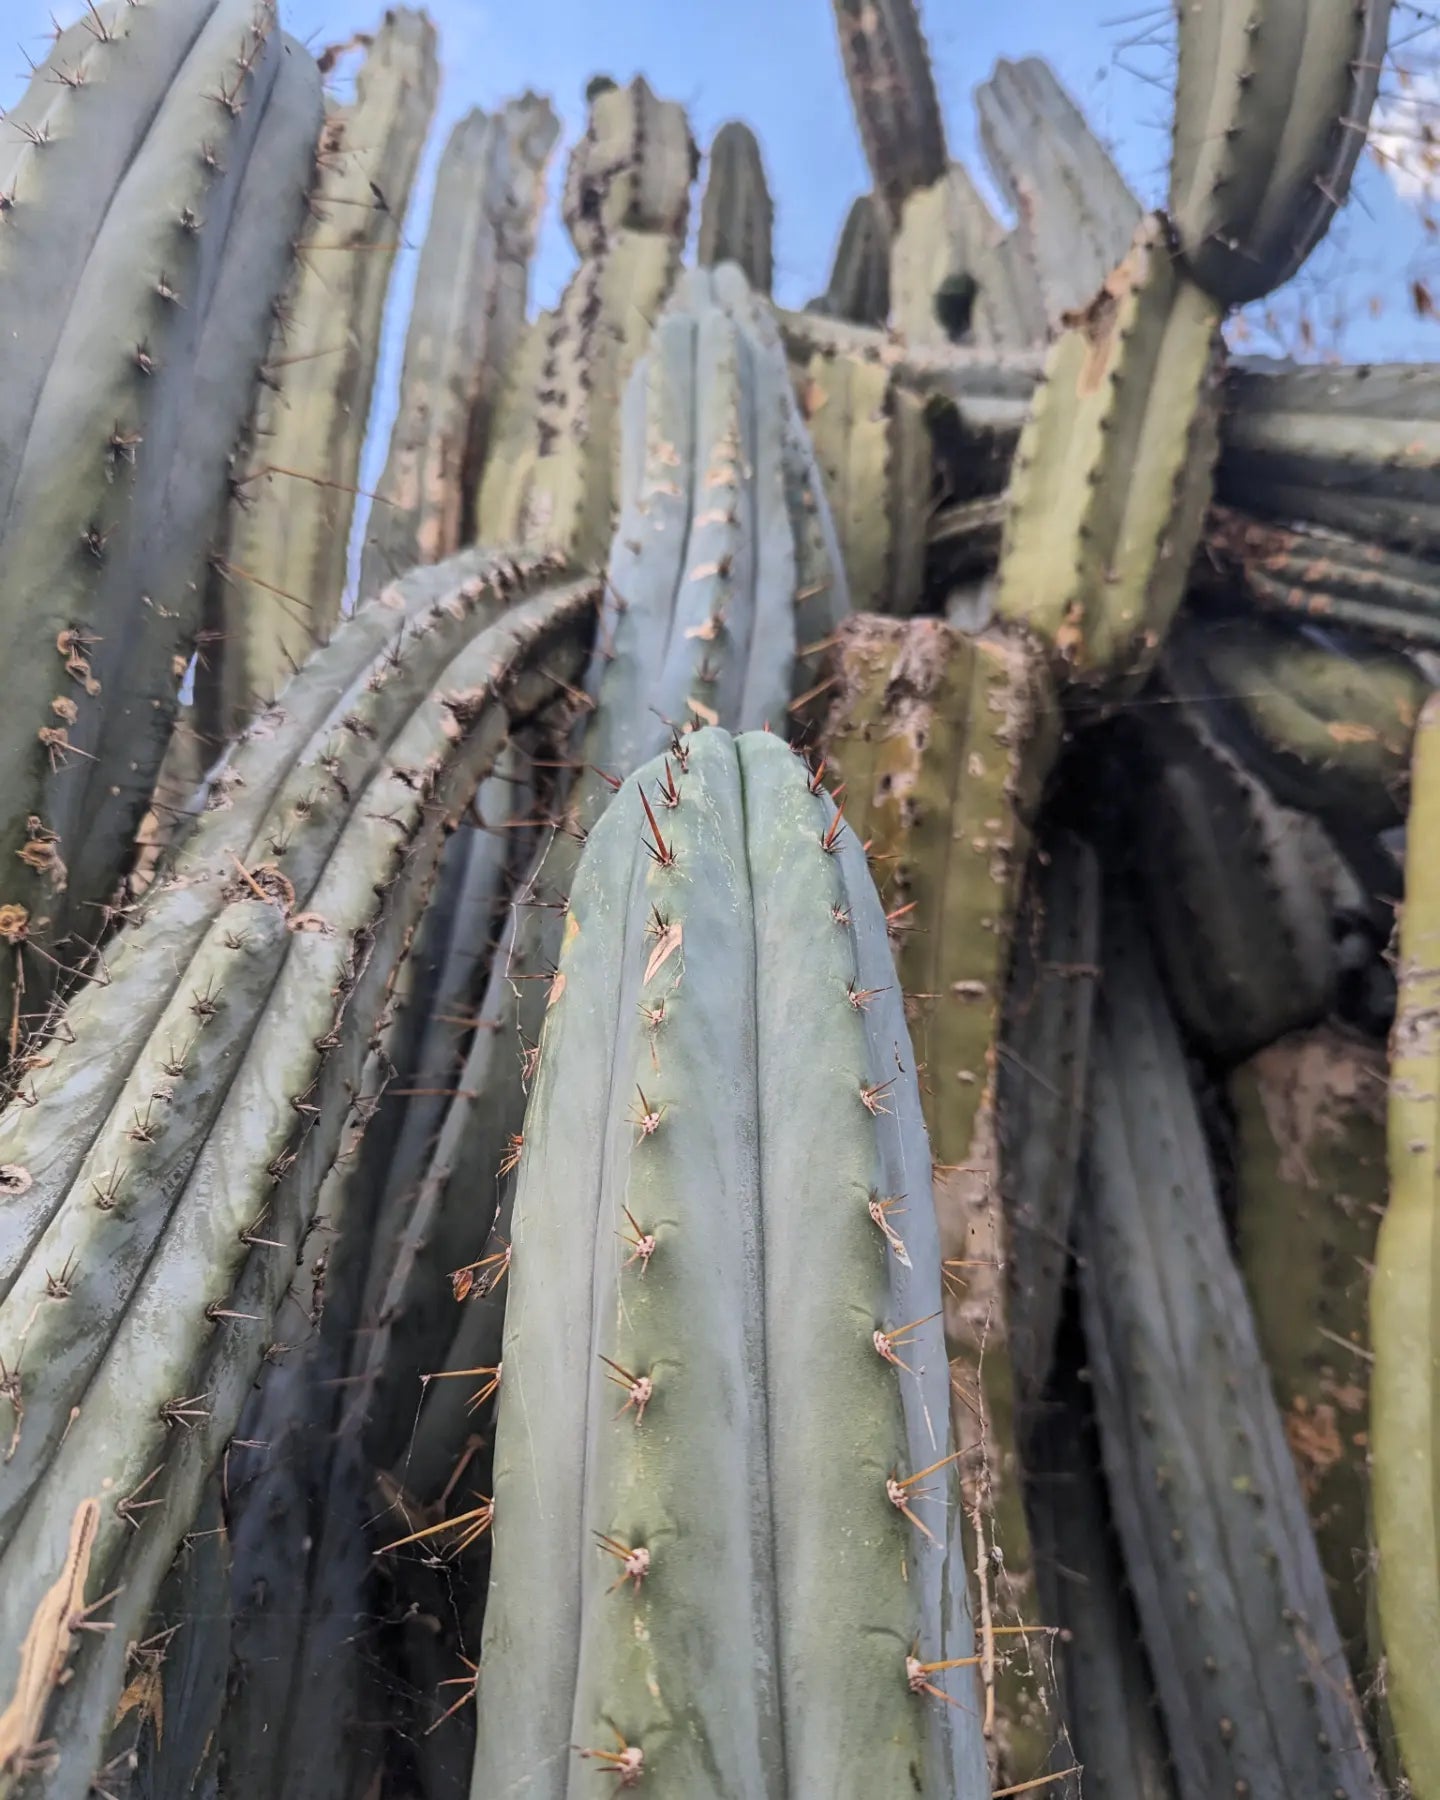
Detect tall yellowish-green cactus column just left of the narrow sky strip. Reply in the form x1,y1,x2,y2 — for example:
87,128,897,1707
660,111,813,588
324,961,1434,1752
196,7,439,743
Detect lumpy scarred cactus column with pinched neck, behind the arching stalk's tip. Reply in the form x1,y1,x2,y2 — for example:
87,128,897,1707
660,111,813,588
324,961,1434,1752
475,77,698,567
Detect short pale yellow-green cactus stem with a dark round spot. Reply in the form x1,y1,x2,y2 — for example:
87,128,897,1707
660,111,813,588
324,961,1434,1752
889,164,1044,351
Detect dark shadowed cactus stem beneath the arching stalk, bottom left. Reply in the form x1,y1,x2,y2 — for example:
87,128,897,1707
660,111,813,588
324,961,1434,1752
101,1471,230,1800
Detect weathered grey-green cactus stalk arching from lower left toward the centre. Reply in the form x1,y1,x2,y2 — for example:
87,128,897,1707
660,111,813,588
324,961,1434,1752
0,563,598,1800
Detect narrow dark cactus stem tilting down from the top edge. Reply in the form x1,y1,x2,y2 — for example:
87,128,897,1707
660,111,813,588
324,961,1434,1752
835,0,949,223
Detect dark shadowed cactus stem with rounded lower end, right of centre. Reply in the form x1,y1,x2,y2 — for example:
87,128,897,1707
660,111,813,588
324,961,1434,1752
1134,689,1341,1064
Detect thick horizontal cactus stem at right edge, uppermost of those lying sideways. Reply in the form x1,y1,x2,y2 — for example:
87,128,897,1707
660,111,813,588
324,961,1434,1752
1217,358,1440,556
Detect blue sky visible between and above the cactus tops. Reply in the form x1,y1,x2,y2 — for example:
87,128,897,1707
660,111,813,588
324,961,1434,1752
0,0,1440,590
